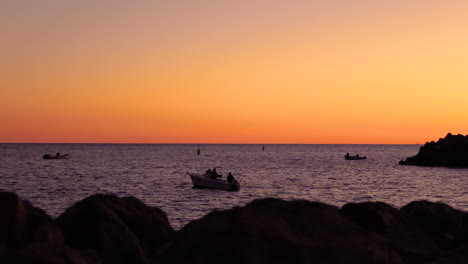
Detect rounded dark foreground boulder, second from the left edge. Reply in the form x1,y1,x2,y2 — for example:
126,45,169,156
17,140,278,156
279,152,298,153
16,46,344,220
57,194,173,264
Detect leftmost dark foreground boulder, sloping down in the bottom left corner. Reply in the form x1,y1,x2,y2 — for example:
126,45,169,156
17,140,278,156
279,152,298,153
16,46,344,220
0,192,99,264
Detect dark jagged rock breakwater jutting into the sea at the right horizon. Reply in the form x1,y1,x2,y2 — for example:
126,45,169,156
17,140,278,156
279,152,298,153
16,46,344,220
400,133,468,168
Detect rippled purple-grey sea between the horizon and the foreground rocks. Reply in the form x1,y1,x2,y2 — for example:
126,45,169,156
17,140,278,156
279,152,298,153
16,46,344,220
0,144,468,229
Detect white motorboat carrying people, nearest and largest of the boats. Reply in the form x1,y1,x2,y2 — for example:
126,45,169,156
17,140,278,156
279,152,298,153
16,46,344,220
187,169,240,191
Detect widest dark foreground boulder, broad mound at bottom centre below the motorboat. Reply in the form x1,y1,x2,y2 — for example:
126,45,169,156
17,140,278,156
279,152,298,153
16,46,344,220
156,198,404,264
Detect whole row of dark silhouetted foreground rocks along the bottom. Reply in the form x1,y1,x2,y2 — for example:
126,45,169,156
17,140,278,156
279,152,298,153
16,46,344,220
0,192,468,264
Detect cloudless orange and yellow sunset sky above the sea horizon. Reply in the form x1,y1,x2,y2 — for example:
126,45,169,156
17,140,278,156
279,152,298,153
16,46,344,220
0,0,468,144
